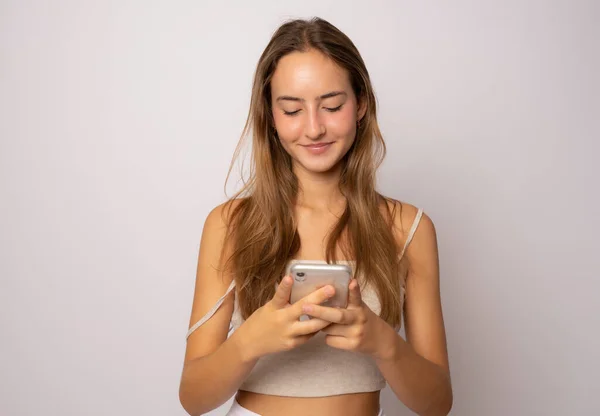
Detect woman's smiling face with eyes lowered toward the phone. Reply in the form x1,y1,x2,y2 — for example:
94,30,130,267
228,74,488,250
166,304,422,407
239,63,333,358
271,50,365,173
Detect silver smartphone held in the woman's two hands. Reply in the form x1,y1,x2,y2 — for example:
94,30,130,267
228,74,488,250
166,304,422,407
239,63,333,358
288,263,352,308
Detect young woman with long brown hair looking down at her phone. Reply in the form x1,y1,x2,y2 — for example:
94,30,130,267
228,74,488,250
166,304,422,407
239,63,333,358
179,19,452,416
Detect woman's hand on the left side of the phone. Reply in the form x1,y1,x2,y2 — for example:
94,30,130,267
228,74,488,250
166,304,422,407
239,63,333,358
235,276,335,359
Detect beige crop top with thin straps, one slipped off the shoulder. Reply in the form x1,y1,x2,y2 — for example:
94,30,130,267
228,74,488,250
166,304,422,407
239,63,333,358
186,209,423,397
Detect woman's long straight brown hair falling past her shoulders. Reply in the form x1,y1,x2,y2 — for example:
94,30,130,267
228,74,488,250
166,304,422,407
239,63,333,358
222,18,406,327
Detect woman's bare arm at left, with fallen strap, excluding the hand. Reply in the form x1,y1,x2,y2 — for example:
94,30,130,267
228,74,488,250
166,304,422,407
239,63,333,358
179,205,257,415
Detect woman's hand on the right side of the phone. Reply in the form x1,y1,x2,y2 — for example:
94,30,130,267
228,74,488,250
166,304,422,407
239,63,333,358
302,279,397,358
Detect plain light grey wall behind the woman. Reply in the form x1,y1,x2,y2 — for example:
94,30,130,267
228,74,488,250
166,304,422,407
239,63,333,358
0,0,600,416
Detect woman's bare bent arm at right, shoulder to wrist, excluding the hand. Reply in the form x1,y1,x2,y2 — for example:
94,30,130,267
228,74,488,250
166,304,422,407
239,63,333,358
376,210,452,415
